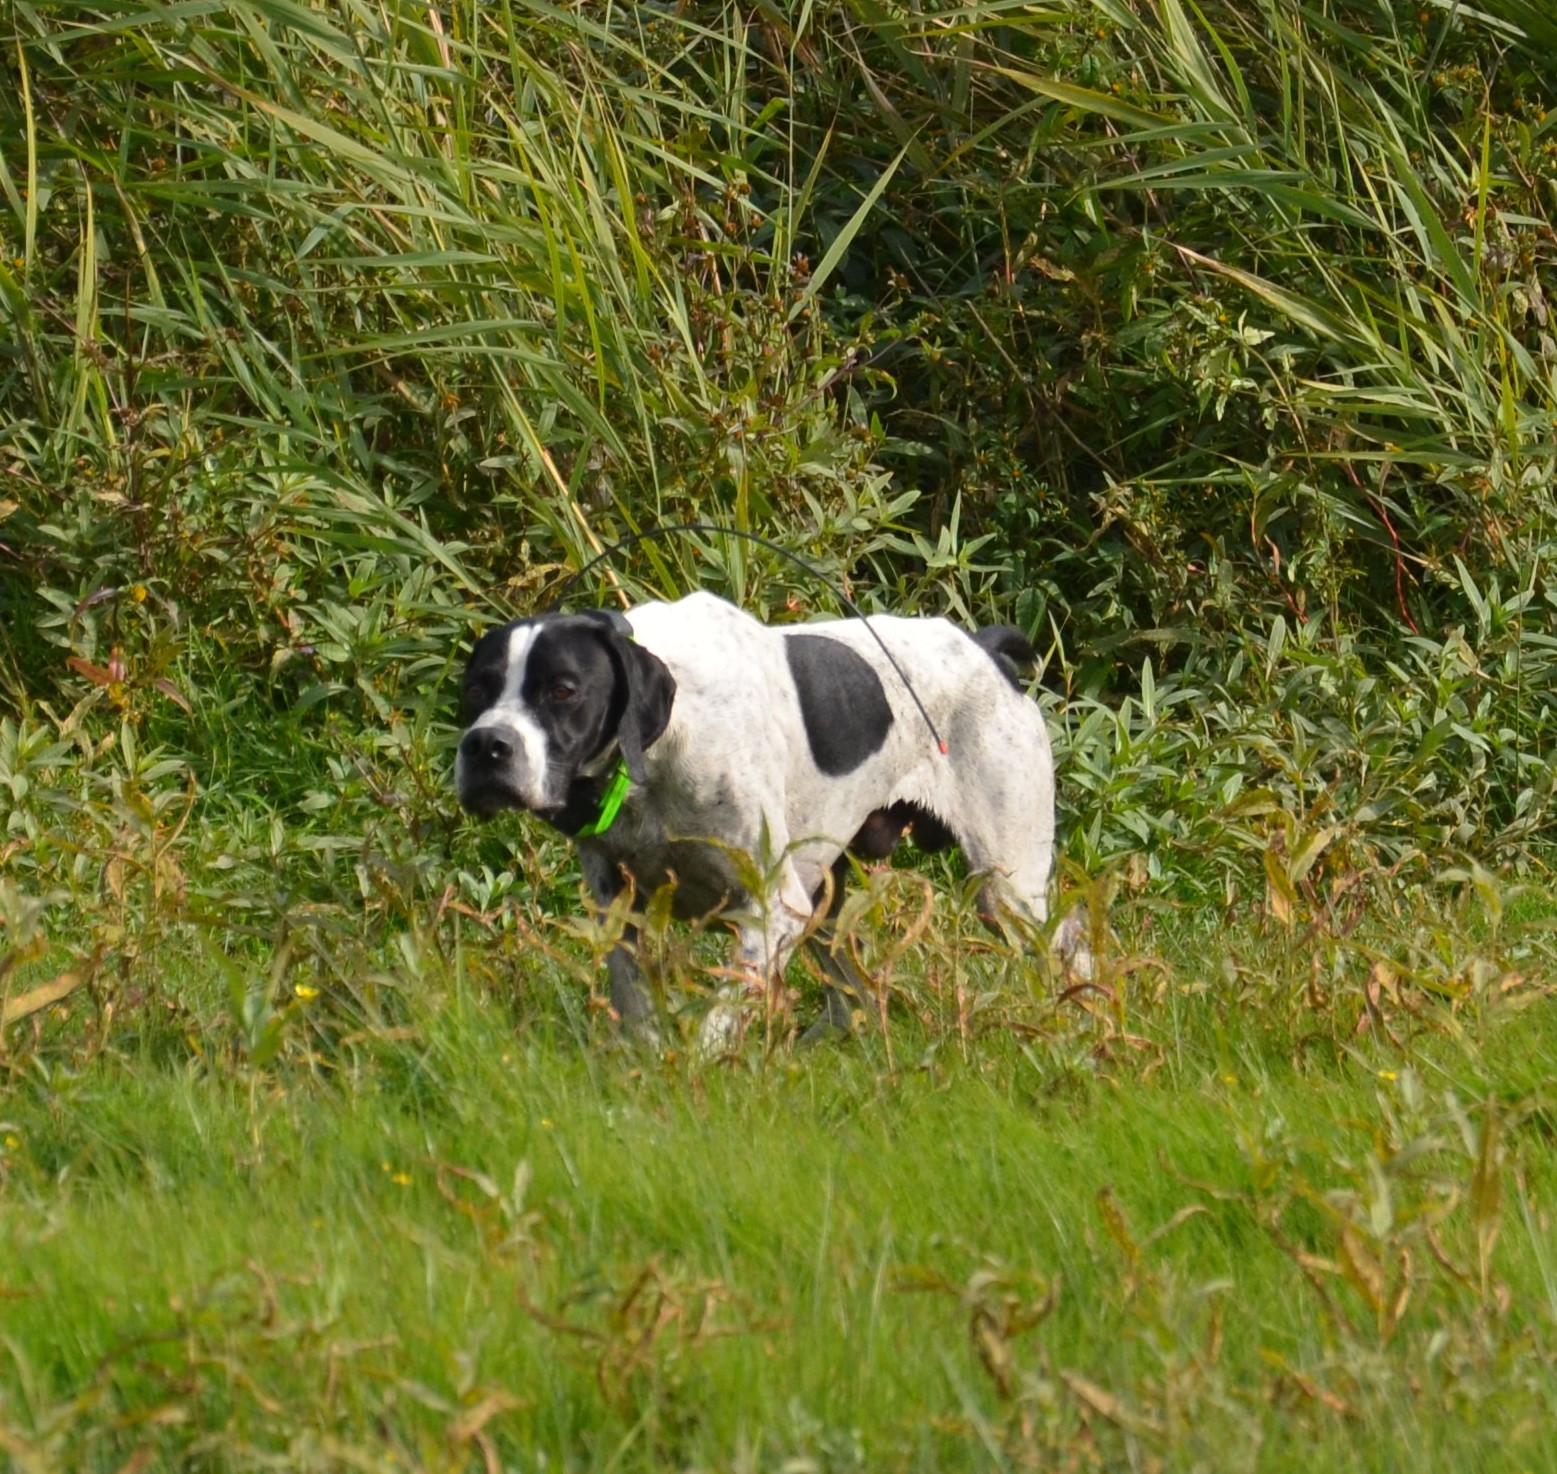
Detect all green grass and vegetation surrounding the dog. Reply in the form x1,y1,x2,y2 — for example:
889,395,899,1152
0,0,1557,1471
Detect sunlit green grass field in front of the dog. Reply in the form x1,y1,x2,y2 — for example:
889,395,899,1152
0,890,1557,1471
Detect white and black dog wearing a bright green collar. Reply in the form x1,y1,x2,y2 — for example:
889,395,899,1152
455,593,1082,1045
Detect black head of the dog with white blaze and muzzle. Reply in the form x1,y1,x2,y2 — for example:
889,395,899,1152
455,612,676,819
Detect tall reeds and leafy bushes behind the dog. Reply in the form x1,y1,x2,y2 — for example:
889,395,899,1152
0,0,1557,1027
